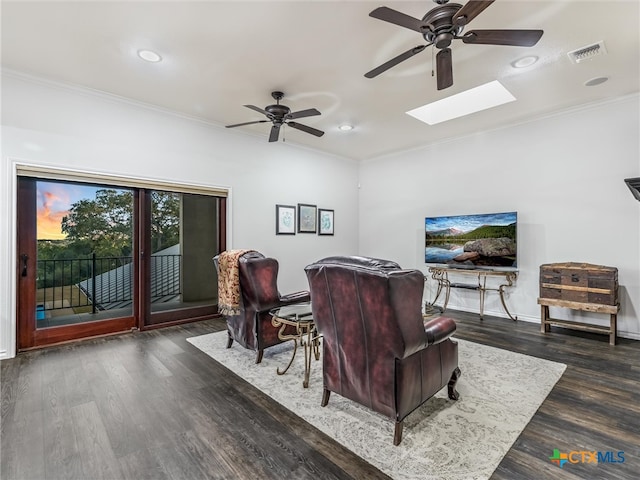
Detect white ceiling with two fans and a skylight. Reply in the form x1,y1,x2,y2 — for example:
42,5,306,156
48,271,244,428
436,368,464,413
1,0,640,160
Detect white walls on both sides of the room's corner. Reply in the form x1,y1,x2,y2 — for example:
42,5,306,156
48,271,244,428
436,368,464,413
0,72,640,358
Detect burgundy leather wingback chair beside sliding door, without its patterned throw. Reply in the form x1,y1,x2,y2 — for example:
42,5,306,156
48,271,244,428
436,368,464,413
213,251,310,363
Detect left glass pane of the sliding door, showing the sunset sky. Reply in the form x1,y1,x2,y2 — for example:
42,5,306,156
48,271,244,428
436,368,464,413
36,181,133,328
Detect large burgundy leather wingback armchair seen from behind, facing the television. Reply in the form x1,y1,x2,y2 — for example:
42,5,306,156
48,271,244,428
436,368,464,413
305,257,460,445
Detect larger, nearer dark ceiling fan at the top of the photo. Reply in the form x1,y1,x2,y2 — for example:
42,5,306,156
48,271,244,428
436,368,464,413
364,0,544,90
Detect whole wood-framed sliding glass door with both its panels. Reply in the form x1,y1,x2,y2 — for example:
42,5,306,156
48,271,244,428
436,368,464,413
17,177,226,349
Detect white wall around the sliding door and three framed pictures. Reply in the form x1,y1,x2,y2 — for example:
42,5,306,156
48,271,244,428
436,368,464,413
0,72,358,358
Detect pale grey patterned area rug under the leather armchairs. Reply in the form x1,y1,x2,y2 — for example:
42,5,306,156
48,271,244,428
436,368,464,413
187,332,566,480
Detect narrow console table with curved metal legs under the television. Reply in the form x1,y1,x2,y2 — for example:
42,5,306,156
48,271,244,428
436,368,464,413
429,267,518,320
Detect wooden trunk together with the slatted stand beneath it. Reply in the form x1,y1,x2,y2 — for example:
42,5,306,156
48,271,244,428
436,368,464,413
538,263,620,345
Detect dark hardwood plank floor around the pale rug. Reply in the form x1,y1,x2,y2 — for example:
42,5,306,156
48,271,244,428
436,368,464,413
0,311,640,480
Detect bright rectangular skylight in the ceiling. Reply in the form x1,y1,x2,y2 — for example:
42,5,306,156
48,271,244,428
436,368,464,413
407,80,516,125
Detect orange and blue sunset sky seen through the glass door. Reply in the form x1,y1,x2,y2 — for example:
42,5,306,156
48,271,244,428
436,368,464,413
37,182,98,240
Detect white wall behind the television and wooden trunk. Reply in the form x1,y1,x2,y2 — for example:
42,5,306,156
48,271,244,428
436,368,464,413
359,95,640,339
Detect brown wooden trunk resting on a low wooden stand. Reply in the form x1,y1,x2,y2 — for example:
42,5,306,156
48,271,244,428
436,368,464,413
540,262,618,305
